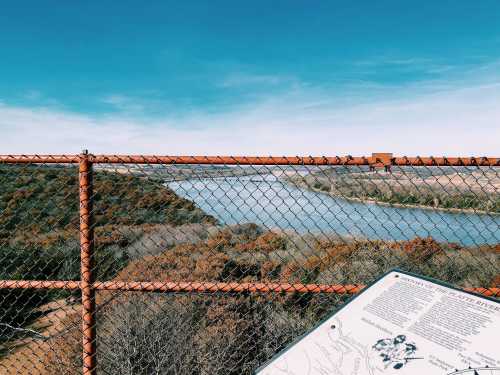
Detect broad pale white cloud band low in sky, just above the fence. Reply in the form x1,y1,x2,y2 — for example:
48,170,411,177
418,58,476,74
0,64,500,156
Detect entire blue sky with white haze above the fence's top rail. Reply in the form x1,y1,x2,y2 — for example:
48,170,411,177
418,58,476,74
0,0,500,154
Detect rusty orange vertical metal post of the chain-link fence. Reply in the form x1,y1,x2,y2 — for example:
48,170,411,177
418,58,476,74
79,150,96,375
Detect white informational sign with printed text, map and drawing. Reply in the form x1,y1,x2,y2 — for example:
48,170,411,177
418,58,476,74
256,271,500,375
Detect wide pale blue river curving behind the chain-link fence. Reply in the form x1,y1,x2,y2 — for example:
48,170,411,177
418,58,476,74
168,175,500,245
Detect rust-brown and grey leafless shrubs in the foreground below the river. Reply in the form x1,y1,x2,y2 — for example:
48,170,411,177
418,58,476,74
47,225,500,375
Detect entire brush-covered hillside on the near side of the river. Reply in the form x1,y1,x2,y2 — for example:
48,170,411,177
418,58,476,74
0,166,500,375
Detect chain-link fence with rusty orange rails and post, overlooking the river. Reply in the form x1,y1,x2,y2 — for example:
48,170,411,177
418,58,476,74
0,153,500,375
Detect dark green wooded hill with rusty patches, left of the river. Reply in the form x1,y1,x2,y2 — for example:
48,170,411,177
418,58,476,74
0,165,213,238
